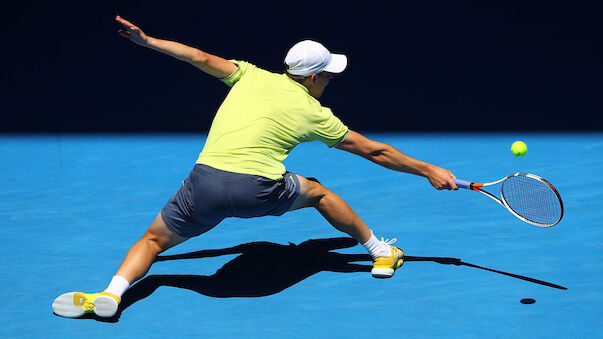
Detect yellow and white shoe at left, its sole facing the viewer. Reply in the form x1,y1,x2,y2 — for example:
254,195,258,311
52,292,120,318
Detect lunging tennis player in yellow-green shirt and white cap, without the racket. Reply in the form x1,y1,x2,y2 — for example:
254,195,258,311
53,16,457,317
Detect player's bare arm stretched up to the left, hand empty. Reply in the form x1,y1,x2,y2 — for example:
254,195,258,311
115,15,237,79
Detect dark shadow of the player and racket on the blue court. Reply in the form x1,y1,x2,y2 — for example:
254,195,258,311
93,238,566,322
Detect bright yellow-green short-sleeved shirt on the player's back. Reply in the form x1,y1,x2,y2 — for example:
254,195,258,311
197,60,349,180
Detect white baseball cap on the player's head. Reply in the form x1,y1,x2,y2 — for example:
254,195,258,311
285,40,348,77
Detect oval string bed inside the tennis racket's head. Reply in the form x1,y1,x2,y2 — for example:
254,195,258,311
501,175,563,225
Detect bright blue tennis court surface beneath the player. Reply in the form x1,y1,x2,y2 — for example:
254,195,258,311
0,133,603,338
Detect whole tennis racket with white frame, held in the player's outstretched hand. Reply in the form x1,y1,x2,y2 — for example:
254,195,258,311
454,173,563,227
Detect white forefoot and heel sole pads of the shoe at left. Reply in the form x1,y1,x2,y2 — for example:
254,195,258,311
52,292,118,318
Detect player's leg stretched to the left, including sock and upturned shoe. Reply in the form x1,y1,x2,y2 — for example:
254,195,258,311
52,212,188,318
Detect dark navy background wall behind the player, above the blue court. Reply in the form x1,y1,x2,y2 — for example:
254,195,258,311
0,1,603,132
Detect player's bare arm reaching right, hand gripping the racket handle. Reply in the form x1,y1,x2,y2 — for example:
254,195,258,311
335,130,458,190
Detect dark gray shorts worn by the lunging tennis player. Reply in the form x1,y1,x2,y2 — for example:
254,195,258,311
161,164,299,238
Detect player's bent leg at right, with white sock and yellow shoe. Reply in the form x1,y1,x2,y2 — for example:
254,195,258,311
289,175,404,278
